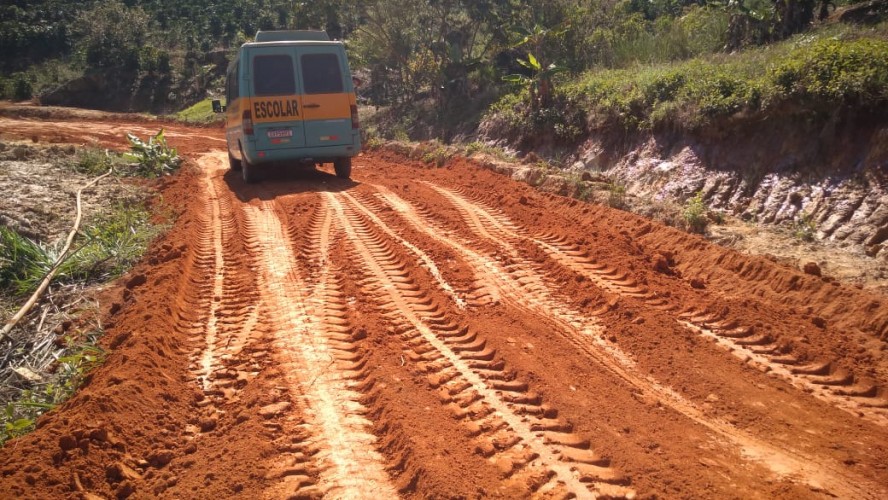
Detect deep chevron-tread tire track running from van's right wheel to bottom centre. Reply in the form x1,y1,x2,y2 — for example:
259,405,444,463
327,189,635,498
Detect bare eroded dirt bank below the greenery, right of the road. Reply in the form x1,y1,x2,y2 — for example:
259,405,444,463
480,107,888,264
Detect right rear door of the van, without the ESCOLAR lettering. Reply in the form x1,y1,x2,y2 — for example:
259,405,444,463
299,46,354,147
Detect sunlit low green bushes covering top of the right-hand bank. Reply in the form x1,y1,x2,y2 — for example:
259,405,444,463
487,27,888,135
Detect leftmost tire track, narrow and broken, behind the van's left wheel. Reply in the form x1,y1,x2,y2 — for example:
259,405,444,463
177,154,317,497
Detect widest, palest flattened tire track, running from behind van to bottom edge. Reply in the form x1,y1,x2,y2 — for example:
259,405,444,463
244,196,397,498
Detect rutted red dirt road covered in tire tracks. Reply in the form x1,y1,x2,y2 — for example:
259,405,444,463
0,118,888,498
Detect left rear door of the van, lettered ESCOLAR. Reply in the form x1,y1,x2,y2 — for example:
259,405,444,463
250,51,305,150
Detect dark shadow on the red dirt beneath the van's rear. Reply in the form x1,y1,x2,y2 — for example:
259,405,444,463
224,166,359,202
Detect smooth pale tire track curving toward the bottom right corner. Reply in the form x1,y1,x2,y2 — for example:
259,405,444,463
367,183,884,498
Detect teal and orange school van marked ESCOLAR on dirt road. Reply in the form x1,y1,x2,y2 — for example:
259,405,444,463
213,31,361,182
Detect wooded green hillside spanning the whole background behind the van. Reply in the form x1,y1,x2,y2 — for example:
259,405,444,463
0,0,888,132
